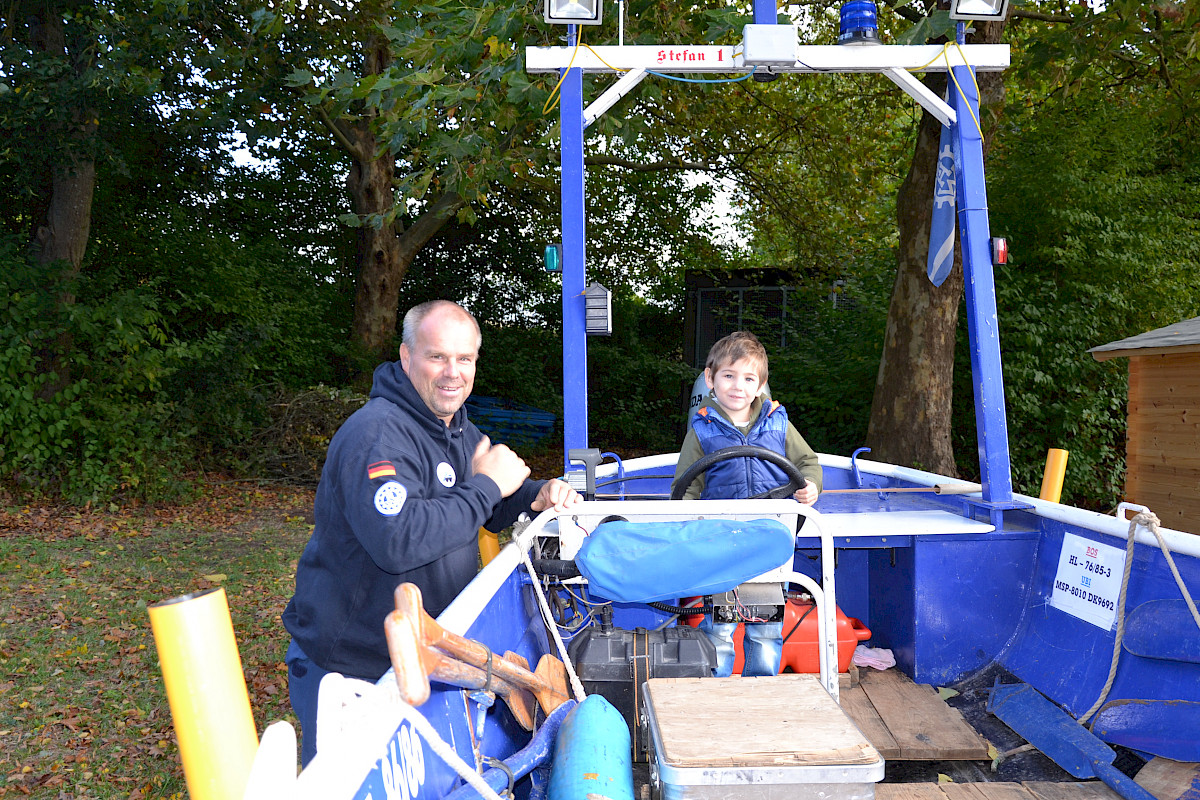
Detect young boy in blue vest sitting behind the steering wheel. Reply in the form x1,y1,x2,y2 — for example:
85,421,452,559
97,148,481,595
672,331,821,678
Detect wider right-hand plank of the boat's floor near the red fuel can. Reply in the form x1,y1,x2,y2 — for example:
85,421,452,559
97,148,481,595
860,669,989,760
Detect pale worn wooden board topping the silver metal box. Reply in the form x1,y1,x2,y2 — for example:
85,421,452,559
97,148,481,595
646,674,881,768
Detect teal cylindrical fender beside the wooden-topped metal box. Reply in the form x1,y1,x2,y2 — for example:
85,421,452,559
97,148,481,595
548,694,634,800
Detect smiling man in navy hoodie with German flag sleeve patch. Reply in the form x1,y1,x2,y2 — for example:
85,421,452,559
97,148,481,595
283,300,580,764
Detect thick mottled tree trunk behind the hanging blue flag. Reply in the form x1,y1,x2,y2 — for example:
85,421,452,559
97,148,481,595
866,23,1004,476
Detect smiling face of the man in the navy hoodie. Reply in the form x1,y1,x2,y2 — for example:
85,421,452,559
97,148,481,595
400,308,479,425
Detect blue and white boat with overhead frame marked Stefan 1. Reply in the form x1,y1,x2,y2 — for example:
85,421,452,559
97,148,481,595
157,2,1200,800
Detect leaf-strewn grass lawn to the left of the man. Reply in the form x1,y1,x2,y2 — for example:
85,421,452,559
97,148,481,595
0,482,312,800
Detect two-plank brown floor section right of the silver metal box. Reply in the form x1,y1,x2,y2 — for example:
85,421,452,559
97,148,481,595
839,668,988,762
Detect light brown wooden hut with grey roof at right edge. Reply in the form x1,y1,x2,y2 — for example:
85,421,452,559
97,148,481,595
1088,317,1200,534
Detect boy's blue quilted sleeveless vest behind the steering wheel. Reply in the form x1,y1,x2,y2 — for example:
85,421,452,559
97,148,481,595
691,402,788,500
